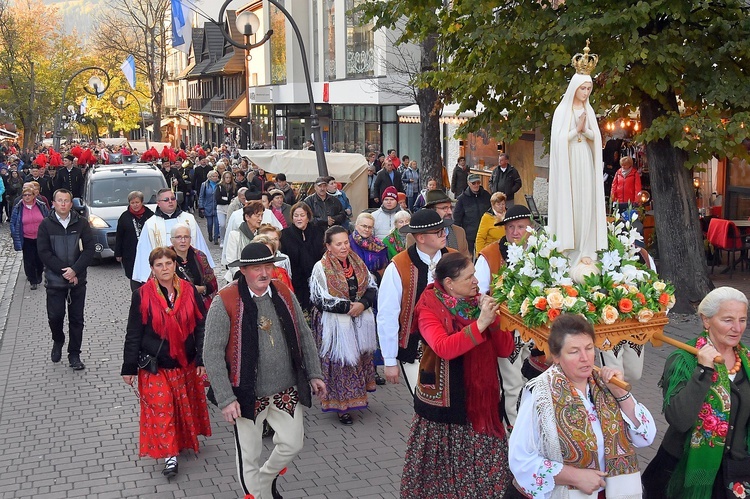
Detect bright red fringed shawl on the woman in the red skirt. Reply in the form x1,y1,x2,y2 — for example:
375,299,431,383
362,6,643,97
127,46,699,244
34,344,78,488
141,276,203,367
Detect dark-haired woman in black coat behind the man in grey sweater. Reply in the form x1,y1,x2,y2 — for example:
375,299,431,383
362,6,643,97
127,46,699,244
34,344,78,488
280,202,325,314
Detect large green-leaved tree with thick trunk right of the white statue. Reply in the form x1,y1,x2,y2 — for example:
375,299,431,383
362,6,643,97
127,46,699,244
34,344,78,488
364,0,750,312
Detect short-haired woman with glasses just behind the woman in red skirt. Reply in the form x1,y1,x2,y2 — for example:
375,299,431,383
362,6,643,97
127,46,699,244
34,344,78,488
170,223,219,310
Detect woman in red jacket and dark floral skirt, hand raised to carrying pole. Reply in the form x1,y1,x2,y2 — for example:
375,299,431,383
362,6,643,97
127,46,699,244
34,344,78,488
401,253,513,498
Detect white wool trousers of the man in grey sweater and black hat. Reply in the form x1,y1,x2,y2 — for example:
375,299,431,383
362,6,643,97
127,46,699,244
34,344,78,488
234,396,305,499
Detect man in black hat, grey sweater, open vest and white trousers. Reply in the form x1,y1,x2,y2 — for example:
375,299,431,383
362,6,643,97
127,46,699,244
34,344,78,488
203,243,326,499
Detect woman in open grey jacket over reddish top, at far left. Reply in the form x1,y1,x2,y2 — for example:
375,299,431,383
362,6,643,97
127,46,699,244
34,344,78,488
10,186,49,290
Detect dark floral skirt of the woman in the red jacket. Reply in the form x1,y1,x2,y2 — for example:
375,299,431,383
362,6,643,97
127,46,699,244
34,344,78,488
401,414,513,499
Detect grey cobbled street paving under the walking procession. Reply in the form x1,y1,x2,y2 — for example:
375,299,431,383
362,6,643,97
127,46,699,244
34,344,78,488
0,221,747,499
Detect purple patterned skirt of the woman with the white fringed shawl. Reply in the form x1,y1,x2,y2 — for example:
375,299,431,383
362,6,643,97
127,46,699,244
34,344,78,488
312,307,377,413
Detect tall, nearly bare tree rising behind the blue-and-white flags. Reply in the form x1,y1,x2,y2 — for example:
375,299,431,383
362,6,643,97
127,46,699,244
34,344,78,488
93,0,172,142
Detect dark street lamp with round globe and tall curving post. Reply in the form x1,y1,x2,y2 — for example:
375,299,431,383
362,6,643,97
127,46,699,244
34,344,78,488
217,0,328,177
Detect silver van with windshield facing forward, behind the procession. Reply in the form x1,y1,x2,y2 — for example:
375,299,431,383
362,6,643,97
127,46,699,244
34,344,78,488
73,163,169,259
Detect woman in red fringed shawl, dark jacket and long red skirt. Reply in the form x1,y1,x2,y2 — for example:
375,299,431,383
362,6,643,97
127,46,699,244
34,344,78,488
120,247,211,478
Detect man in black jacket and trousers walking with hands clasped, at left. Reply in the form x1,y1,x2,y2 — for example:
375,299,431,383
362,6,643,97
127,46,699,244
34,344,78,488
36,189,96,371
